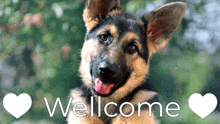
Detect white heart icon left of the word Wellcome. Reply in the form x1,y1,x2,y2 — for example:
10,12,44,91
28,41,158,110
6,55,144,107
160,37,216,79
3,93,32,118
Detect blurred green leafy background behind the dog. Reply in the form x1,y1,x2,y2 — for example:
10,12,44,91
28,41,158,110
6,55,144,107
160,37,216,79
0,0,220,124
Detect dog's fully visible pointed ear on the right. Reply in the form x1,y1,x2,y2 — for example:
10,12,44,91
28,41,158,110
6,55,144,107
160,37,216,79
138,2,186,54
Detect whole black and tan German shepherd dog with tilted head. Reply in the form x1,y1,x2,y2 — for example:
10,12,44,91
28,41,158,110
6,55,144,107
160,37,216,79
67,0,186,124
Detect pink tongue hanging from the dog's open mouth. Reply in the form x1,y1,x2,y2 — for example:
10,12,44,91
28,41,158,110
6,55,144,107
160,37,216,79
95,79,114,94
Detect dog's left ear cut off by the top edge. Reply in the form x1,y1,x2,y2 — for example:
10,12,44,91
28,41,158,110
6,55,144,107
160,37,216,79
83,0,121,31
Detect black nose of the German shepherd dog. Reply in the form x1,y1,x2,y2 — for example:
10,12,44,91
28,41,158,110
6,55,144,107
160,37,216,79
99,61,117,78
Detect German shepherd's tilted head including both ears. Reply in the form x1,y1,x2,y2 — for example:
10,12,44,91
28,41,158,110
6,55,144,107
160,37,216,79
80,0,186,96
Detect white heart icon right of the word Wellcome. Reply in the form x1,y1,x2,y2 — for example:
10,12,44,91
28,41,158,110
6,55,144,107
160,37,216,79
188,93,218,118
